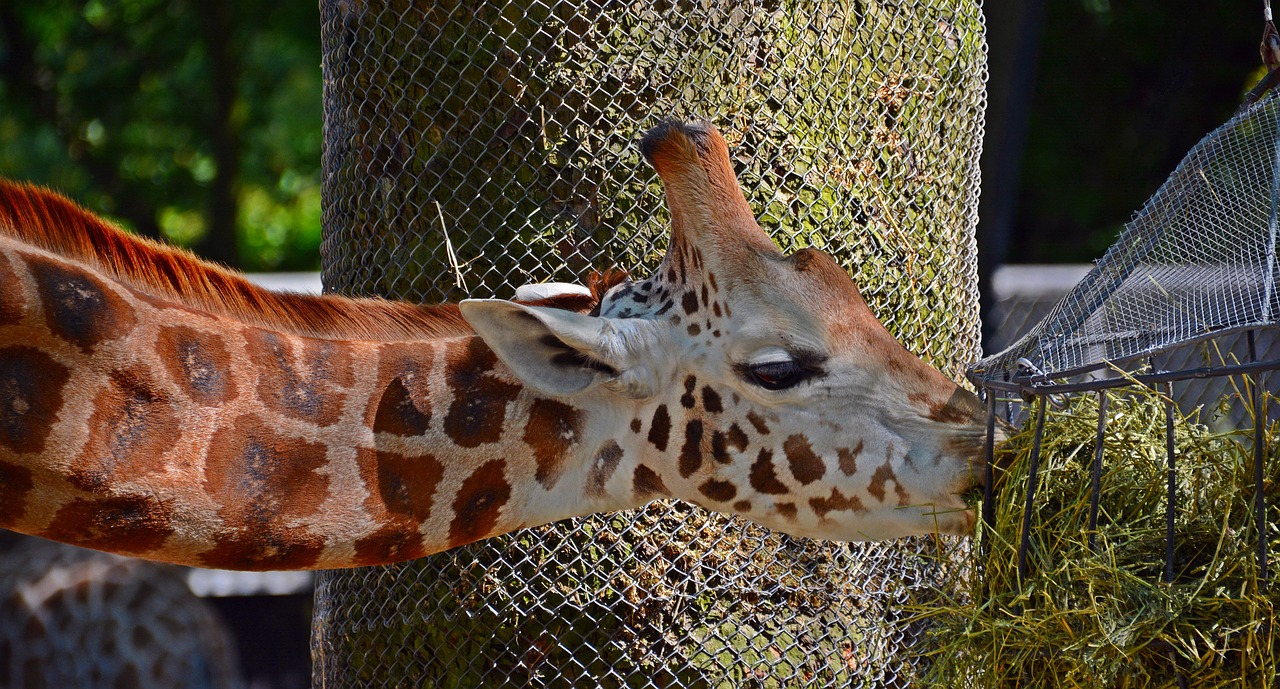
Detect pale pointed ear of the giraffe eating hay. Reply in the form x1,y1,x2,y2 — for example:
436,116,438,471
458,300,650,397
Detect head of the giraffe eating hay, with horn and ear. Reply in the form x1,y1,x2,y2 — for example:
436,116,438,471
461,124,986,540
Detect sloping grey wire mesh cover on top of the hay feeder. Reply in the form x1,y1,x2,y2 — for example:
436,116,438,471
973,87,1280,380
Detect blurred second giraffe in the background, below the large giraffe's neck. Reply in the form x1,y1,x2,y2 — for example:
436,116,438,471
0,531,244,689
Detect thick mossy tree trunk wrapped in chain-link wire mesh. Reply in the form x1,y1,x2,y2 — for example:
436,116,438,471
312,0,986,686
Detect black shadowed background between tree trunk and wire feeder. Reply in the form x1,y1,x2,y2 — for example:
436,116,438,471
979,0,1262,263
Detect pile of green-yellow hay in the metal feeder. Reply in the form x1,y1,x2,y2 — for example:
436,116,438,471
919,379,1280,689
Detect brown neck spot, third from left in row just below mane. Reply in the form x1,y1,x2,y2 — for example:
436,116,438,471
156,325,237,405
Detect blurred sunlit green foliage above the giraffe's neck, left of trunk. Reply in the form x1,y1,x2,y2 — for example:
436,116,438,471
0,0,321,270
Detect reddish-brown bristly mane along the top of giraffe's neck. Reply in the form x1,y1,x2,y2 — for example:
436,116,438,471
0,179,626,341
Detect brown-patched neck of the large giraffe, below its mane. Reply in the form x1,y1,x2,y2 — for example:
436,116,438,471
0,233,635,569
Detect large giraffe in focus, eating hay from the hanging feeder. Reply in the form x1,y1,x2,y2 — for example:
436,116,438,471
0,122,986,570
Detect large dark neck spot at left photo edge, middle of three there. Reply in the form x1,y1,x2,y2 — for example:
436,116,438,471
0,346,70,452
